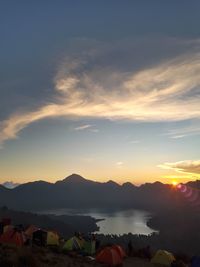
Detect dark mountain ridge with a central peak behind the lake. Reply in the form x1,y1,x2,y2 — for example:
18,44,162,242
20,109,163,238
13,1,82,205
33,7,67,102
0,174,191,211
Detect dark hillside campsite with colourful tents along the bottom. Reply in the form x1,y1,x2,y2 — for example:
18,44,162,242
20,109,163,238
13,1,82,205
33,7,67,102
0,218,195,267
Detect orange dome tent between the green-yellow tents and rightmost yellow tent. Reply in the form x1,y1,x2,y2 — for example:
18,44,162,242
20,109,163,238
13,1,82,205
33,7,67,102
96,247,123,266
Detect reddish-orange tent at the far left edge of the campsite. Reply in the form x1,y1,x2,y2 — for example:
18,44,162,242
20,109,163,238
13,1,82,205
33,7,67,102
0,230,25,246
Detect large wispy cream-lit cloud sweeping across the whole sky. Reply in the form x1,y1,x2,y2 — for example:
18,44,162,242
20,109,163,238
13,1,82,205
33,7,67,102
0,40,200,144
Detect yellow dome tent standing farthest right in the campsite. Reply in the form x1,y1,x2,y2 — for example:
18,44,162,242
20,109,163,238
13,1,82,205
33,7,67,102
151,250,175,266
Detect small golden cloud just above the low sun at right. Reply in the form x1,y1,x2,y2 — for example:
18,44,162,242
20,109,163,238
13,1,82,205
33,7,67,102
158,160,200,175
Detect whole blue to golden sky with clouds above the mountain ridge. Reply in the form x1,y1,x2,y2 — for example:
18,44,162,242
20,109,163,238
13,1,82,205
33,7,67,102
0,0,200,184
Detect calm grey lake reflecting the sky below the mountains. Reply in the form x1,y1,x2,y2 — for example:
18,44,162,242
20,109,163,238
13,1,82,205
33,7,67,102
39,209,155,235
